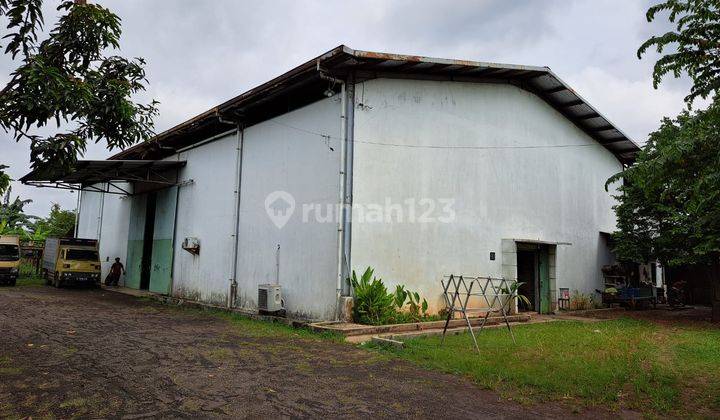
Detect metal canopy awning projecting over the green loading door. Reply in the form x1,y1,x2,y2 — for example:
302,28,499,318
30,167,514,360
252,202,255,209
20,160,186,195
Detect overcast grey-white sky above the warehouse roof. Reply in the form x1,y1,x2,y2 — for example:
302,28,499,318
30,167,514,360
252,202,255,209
0,0,689,215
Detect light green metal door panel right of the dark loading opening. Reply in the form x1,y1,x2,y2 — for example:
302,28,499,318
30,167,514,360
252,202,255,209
150,187,178,295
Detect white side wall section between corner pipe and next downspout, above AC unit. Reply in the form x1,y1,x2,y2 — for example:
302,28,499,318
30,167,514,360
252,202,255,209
233,95,341,319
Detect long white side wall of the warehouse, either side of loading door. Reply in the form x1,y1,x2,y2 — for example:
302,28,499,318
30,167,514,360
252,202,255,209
79,96,341,319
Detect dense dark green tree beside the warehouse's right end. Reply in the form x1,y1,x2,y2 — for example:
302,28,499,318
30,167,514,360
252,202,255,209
609,104,720,265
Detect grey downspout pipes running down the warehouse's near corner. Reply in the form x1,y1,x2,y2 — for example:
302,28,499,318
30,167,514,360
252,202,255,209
317,60,355,320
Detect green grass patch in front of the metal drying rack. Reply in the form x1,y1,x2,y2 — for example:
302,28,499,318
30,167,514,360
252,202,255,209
371,319,720,414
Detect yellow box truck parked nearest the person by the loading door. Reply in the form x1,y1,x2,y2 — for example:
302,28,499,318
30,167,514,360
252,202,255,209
42,238,100,287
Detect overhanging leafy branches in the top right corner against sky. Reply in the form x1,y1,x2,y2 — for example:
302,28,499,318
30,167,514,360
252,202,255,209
637,0,720,105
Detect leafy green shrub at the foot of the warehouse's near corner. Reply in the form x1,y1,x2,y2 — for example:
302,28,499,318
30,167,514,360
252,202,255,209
350,267,396,325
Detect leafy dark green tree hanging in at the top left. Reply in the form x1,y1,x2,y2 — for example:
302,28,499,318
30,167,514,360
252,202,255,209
0,0,157,194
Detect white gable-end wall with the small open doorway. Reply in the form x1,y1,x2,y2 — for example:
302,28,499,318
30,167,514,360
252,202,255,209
352,79,621,309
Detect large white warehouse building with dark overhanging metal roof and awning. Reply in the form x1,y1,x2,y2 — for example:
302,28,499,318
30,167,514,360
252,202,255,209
23,46,638,320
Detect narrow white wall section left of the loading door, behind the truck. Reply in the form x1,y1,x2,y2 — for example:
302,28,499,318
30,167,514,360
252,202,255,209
78,183,130,283
